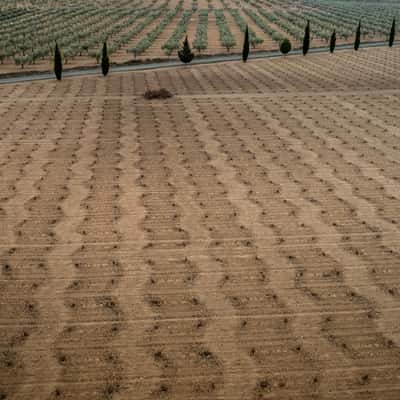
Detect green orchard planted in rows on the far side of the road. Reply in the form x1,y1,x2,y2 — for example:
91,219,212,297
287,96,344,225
0,0,400,68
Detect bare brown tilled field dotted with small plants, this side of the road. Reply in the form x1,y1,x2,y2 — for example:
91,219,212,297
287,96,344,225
0,49,400,400
